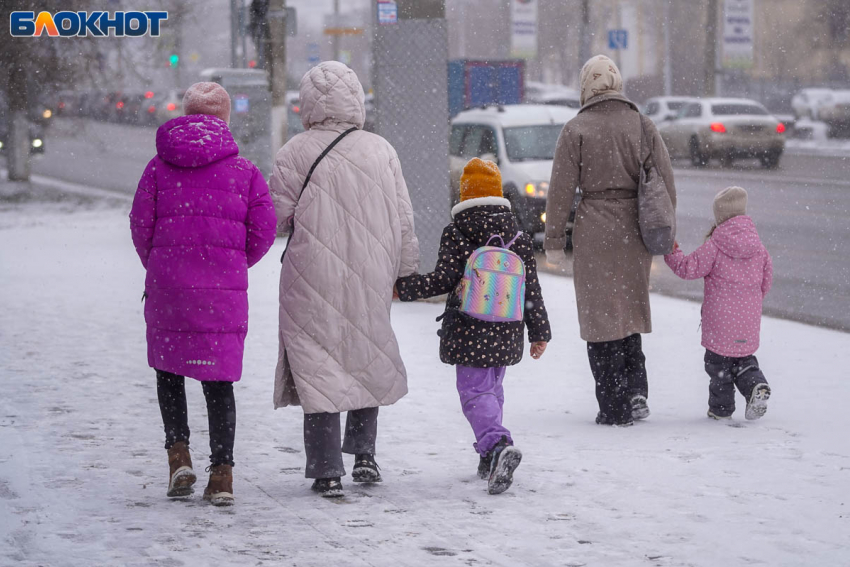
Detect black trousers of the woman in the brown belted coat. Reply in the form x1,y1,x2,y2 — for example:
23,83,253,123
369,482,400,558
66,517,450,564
587,334,649,425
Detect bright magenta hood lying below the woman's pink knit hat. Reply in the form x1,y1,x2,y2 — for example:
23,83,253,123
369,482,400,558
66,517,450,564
156,114,239,167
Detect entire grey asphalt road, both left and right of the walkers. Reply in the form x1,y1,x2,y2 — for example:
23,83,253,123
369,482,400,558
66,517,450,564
6,120,850,332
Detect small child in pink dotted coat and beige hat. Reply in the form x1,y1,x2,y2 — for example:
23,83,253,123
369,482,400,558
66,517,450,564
664,187,773,419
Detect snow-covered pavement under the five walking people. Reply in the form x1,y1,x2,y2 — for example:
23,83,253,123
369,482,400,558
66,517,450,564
0,203,850,567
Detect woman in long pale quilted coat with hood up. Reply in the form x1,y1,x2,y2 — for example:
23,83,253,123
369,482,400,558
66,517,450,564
270,61,419,497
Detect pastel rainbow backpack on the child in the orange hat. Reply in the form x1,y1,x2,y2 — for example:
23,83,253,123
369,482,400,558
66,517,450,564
457,232,525,322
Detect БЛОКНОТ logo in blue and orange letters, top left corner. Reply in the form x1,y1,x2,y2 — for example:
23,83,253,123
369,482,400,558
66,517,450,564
9,11,168,37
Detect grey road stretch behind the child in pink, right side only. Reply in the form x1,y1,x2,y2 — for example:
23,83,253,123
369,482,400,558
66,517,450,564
541,155,850,332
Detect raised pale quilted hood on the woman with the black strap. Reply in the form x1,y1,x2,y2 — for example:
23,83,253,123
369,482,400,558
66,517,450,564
301,61,366,130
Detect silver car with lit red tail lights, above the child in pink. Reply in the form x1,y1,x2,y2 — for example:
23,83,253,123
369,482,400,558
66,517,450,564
658,98,785,169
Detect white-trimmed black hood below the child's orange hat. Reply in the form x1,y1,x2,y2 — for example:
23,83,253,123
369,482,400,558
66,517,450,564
452,197,519,247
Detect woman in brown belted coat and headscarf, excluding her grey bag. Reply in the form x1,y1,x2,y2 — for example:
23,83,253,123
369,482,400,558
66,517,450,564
544,55,676,425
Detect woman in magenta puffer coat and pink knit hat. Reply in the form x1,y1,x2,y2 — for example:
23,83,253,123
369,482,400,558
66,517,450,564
130,83,276,505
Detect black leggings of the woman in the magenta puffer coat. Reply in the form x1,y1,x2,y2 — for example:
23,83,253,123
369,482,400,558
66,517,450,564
156,370,236,466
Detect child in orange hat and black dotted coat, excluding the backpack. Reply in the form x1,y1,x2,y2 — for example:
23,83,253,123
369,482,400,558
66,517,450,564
396,158,552,494
